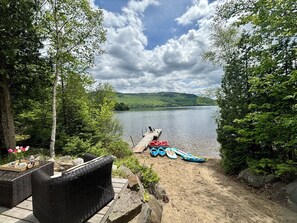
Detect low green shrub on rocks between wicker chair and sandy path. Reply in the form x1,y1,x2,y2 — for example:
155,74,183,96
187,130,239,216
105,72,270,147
116,156,160,188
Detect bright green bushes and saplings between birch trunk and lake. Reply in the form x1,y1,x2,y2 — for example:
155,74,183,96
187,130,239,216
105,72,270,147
56,81,132,158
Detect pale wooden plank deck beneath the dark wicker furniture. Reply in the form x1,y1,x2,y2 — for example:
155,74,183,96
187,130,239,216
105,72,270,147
0,178,128,223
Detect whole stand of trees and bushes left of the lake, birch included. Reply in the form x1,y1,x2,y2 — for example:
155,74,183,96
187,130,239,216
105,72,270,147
0,0,128,157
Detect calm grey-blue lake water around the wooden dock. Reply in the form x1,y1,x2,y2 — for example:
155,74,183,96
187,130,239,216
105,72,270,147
116,106,220,158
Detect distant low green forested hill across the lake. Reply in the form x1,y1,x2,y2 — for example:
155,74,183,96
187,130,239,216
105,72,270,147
117,92,216,108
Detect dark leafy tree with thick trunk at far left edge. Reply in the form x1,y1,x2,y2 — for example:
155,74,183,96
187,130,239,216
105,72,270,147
0,0,49,150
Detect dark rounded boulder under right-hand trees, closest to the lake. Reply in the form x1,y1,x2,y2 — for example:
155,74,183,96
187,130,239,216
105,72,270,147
237,168,265,188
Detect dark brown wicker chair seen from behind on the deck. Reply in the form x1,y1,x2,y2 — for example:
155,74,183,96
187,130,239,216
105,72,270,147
32,156,114,223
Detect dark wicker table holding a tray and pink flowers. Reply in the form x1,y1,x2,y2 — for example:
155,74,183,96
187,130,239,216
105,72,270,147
0,161,54,208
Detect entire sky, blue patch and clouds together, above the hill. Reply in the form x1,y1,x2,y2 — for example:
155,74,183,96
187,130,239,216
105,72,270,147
92,0,223,95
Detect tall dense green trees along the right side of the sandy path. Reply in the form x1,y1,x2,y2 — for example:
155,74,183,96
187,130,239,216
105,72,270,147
204,0,297,179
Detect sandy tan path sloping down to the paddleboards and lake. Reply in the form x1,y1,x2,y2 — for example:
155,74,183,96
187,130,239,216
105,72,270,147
137,153,297,223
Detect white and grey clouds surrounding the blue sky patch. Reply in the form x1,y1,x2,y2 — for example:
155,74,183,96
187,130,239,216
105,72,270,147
92,0,222,94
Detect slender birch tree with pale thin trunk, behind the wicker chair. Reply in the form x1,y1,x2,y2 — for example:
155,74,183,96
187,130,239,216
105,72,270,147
40,0,105,157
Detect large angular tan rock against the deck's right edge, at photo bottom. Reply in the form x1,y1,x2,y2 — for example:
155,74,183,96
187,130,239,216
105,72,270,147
107,189,142,223
